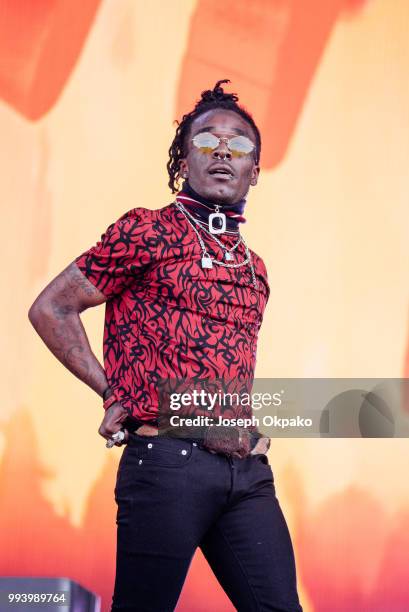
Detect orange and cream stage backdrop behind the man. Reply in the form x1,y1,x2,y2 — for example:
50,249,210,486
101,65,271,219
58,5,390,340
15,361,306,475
0,0,409,612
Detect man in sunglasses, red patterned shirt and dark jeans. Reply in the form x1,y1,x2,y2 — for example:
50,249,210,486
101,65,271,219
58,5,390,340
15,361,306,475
29,81,302,612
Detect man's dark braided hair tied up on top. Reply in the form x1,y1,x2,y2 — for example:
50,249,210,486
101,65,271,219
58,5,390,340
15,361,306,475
166,79,261,193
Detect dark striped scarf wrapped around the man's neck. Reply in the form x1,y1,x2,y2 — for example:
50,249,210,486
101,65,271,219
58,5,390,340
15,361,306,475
176,181,246,232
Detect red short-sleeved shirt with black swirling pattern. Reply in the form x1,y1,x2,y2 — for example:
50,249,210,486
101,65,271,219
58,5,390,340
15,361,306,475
75,203,270,422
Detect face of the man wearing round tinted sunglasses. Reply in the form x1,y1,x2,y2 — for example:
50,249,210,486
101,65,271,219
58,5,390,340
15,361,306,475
180,109,260,204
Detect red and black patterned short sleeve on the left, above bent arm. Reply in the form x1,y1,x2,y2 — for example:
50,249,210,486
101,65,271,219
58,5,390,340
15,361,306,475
74,208,156,299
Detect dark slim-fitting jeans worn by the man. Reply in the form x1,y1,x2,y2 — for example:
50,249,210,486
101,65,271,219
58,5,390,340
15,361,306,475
112,434,302,612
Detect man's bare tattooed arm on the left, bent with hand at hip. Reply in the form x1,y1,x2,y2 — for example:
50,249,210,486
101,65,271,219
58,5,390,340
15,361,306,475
28,262,127,438
